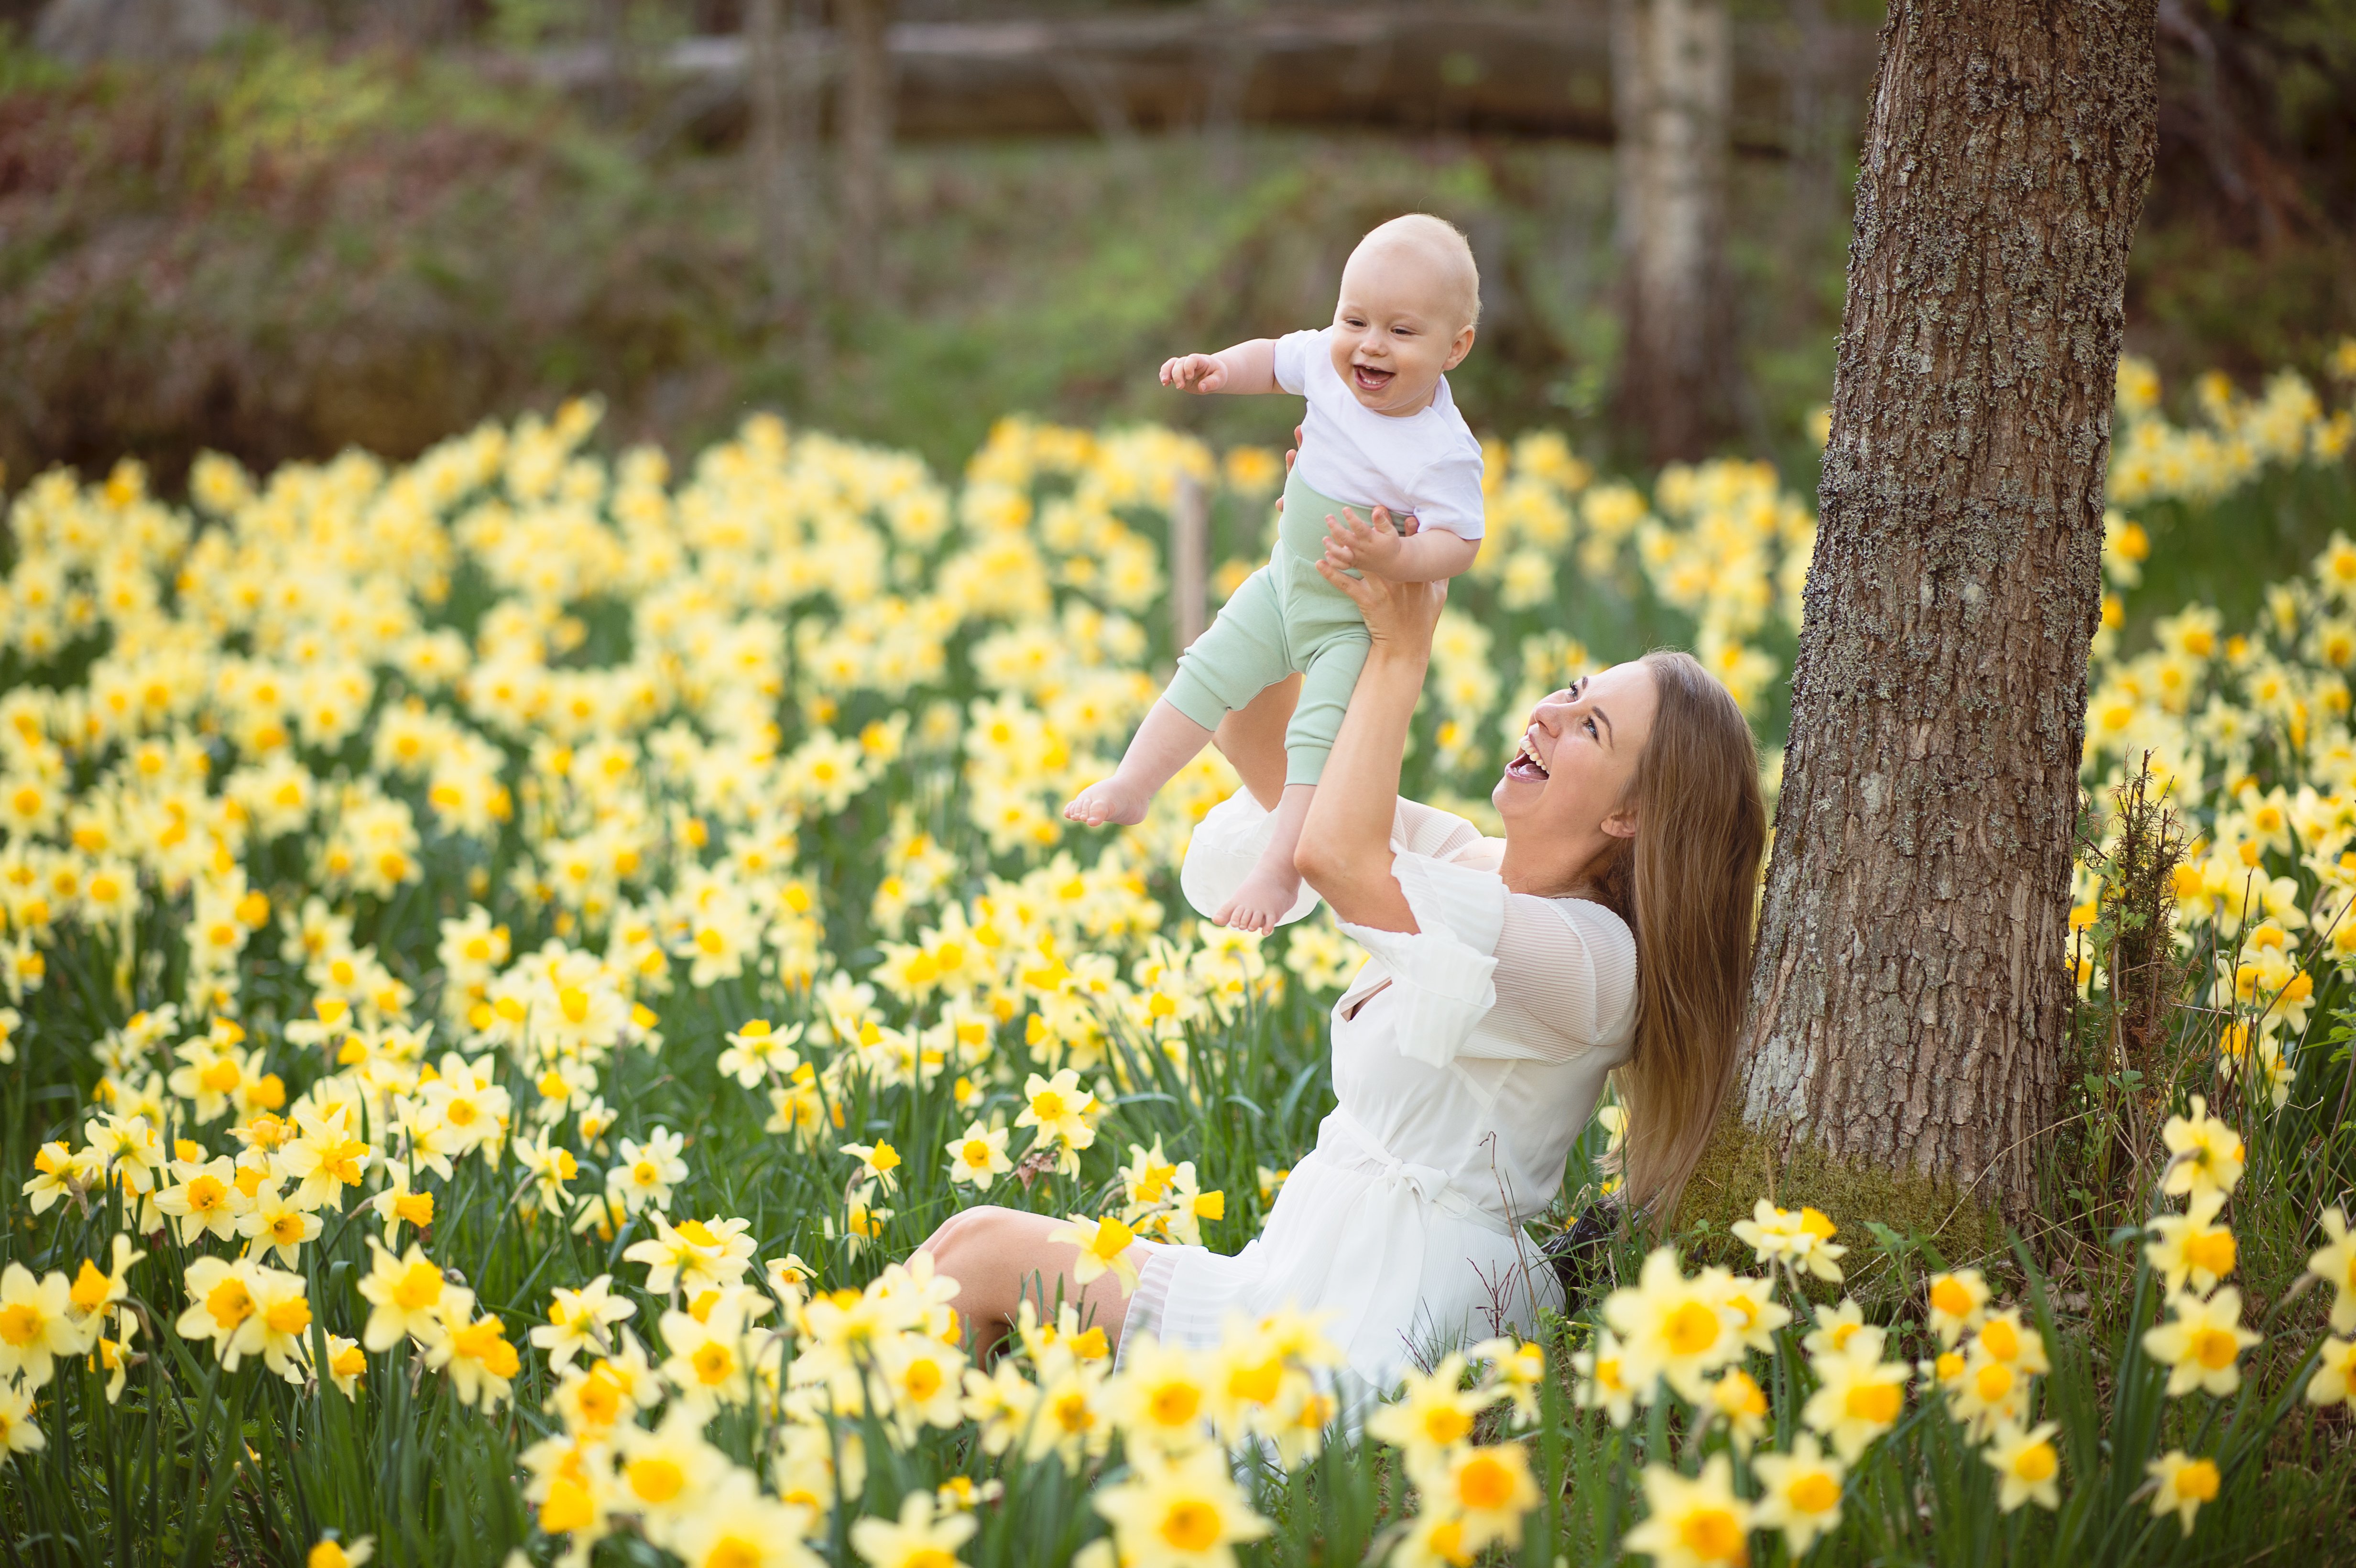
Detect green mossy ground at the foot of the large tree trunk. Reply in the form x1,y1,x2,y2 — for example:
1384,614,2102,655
1673,1109,2010,1297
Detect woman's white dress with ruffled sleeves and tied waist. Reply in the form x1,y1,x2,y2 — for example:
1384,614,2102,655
1124,791,1637,1389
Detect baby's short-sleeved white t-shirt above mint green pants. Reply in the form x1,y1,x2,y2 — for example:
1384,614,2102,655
1277,327,1482,539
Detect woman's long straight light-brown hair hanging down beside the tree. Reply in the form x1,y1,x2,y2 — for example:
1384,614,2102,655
1586,650,1767,1224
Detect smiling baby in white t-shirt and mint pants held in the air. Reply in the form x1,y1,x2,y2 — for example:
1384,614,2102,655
1063,214,1482,932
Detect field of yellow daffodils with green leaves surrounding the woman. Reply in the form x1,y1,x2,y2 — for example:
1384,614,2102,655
0,344,2356,1568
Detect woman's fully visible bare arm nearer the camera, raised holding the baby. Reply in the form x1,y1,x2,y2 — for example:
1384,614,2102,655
1293,544,1449,932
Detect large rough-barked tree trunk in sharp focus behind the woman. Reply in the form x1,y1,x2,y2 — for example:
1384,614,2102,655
1727,0,2156,1227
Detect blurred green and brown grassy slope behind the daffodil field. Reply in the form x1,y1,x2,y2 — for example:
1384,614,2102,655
0,12,2356,565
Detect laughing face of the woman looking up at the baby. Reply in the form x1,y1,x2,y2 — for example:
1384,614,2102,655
1489,664,1658,857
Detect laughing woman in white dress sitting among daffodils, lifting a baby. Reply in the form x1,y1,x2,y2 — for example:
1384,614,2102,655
926,558,1765,1389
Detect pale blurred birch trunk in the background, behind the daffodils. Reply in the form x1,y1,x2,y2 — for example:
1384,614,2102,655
1612,0,1734,461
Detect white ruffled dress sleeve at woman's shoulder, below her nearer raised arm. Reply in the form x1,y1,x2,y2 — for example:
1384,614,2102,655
1341,847,1505,1067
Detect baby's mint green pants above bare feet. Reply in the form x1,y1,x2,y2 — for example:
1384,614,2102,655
1162,468,1371,784
